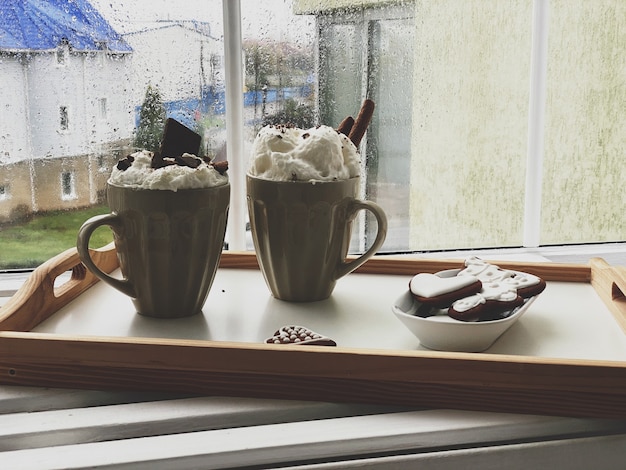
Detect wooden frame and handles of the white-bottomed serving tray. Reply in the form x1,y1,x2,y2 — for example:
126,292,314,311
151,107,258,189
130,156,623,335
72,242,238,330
0,245,626,418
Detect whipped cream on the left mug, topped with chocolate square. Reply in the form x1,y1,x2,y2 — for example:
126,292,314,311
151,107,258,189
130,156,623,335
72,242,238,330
109,150,228,191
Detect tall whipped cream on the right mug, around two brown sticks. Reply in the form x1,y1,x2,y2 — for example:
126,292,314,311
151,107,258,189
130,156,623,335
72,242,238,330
249,126,360,181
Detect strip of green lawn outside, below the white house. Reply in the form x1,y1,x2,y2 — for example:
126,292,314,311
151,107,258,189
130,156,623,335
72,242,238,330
0,205,113,269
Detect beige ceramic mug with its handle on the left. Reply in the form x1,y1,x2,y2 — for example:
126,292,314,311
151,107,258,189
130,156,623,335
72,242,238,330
77,184,230,318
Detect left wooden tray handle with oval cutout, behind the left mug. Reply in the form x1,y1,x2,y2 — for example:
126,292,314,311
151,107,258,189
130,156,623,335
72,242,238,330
0,243,119,331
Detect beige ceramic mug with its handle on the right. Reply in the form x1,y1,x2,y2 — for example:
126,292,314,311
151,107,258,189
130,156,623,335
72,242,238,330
246,174,387,302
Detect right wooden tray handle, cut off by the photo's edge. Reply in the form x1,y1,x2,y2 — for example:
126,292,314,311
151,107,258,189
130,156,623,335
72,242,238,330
589,258,626,333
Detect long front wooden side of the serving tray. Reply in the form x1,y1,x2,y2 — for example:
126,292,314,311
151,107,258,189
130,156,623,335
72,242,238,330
0,332,626,418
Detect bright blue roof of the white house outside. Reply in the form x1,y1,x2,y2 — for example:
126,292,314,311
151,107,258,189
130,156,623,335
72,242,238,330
0,0,132,52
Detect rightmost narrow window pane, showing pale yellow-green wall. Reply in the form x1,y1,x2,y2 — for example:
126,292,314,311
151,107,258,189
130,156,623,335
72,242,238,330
541,0,626,244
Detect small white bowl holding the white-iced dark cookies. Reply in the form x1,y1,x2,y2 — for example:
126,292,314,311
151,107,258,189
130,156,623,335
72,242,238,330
391,270,536,352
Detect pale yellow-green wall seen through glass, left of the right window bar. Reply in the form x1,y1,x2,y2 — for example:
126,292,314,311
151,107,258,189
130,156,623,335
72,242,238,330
410,0,533,249
